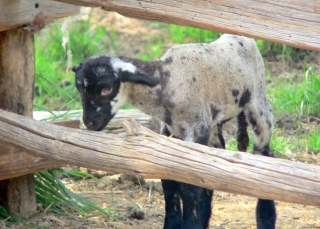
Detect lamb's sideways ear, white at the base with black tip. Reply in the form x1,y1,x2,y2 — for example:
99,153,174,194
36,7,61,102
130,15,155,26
111,57,159,87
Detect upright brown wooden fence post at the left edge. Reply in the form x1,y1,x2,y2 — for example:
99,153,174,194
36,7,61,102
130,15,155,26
0,30,37,218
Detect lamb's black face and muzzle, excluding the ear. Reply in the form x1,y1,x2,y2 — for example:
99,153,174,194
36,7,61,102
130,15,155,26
73,56,120,131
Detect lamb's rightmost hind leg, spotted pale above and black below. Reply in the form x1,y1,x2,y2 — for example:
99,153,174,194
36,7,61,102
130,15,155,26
246,108,277,229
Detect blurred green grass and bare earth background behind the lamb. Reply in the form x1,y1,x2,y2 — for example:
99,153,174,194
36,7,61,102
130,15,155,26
34,8,320,156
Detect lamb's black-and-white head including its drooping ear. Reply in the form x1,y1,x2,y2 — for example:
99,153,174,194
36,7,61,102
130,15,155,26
72,55,159,130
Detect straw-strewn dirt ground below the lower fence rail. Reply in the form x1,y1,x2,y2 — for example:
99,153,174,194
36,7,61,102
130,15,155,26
4,170,320,229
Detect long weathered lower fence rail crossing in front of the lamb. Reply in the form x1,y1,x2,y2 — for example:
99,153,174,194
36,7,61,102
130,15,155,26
0,110,320,205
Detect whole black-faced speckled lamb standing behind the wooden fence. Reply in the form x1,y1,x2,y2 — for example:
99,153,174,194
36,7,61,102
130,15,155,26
74,35,275,229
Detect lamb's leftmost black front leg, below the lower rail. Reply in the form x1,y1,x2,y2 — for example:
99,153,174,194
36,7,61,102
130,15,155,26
161,180,182,229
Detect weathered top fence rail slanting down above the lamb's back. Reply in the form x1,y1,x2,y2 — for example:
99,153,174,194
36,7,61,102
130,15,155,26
50,0,320,51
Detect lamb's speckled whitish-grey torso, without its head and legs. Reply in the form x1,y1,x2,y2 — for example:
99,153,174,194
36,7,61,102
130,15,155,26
122,35,272,148
